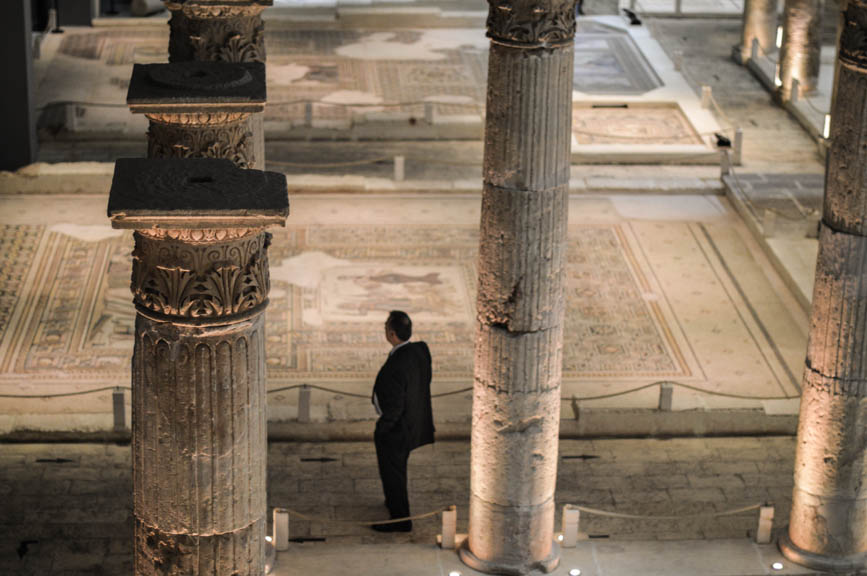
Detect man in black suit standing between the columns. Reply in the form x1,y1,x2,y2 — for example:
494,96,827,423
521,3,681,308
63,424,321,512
372,310,434,532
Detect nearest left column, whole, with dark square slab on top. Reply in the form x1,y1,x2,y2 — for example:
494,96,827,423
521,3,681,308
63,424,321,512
108,159,289,576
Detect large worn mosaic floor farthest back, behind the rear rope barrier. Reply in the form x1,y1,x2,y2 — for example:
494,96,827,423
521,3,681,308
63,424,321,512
36,19,661,133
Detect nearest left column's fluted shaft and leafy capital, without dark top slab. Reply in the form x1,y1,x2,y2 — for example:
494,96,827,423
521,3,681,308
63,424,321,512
132,230,267,576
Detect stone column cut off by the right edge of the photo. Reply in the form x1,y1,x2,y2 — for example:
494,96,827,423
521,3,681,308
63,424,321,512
780,0,867,572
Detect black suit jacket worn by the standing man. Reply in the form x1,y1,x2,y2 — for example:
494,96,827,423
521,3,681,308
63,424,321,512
373,342,434,450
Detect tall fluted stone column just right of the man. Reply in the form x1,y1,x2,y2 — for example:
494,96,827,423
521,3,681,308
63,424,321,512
461,0,575,574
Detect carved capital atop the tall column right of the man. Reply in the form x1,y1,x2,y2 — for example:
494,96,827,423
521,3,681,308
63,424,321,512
488,0,575,47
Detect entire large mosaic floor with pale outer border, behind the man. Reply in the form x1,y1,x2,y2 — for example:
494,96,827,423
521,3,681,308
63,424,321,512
0,197,805,426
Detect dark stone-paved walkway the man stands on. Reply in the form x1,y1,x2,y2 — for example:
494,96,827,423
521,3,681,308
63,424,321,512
0,437,795,576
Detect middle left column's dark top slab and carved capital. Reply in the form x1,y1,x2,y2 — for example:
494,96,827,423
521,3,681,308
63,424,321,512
127,62,265,168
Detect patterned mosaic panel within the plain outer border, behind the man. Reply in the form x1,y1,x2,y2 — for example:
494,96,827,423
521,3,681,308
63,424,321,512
0,226,689,383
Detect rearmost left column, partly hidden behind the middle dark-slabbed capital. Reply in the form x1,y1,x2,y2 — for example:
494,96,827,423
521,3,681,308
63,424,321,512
164,0,274,167
